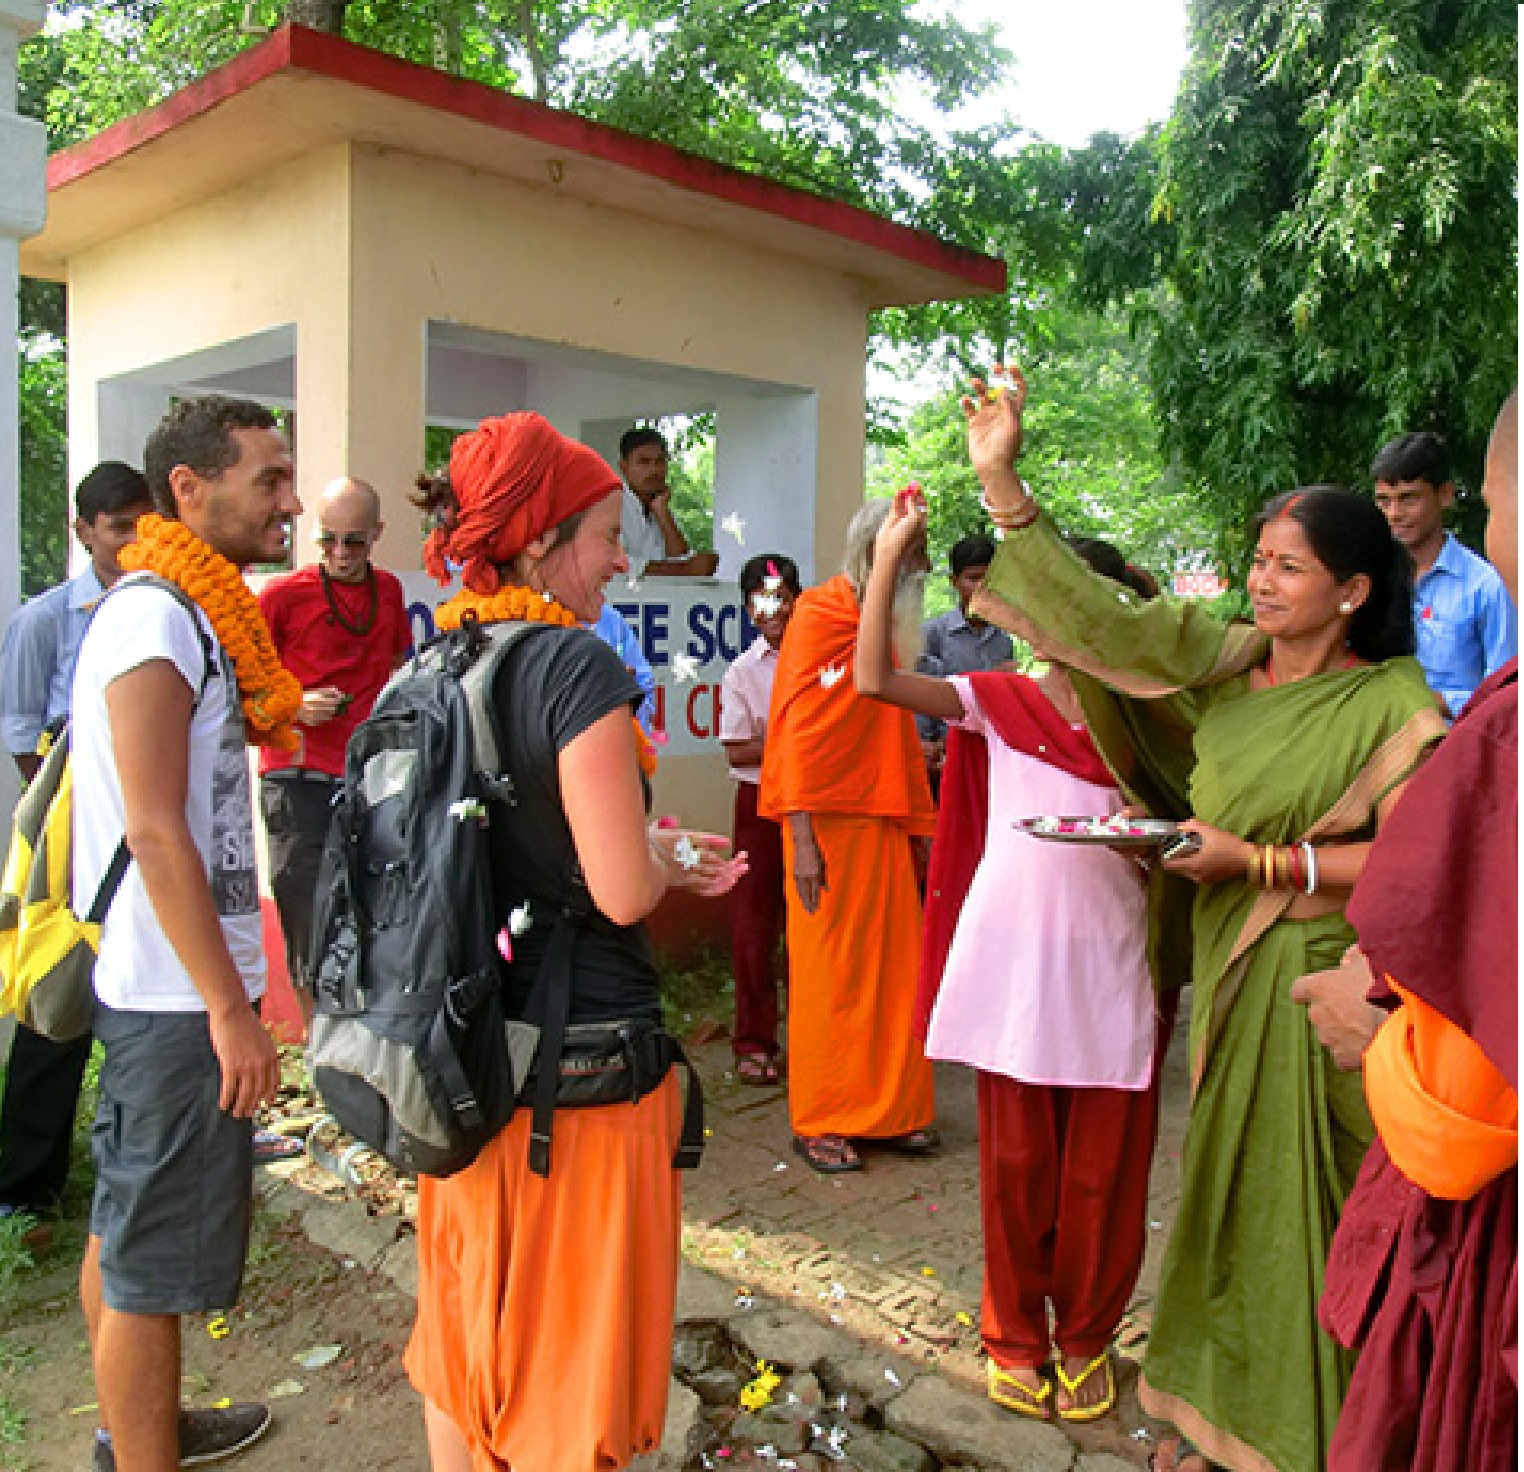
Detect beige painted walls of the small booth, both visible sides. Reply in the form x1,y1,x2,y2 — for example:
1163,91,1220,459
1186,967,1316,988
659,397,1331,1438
69,143,890,853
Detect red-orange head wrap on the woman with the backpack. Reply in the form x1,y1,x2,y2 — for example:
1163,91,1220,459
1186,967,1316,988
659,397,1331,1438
424,413,620,596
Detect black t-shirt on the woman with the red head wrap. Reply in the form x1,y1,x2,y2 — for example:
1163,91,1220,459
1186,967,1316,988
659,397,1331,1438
489,628,661,1022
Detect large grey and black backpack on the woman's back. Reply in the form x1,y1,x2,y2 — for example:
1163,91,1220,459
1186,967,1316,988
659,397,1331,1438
311,622,541,1176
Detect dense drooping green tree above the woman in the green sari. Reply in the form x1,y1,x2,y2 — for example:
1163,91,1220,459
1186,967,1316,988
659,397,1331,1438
1139,0,1518,563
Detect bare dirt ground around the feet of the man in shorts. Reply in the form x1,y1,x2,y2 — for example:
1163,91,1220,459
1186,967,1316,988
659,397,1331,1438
0,1219,428,1472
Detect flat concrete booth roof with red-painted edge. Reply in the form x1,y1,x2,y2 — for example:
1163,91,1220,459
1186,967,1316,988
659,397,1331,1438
21,24,1006,306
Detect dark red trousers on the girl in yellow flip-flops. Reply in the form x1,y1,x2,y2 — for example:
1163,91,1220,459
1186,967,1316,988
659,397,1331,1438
978,995,1175,1368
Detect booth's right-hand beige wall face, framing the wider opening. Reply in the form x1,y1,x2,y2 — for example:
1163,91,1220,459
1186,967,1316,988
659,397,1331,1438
352,148,867,565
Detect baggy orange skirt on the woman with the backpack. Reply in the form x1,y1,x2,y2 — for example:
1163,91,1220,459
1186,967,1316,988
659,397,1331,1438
404,1076,683,1472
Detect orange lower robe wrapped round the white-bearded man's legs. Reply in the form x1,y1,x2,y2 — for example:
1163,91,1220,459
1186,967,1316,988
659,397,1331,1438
783,814,936,1140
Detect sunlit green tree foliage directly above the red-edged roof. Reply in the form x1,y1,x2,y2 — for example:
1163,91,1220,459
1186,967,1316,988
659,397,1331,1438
20,0,1009,230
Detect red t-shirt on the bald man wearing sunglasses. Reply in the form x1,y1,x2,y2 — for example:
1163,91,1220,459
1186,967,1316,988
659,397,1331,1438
259,562,413,777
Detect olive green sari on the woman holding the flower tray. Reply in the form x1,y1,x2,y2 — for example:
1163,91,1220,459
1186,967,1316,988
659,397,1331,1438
975,520,1443,1472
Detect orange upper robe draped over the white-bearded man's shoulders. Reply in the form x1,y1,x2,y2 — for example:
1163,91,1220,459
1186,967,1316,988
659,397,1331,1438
757,576,936,834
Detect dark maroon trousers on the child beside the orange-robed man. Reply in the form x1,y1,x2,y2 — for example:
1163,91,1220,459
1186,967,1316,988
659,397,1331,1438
730,782,785,1058
